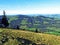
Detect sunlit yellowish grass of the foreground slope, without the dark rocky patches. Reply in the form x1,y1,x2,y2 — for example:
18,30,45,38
0,28,60,45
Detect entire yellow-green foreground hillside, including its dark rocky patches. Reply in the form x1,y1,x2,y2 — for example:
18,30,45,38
0,28,60,45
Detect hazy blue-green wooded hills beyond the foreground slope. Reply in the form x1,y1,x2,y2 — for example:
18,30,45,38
0,14,60,32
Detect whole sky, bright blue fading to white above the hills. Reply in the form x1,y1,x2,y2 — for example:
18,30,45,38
0,0,60,15
